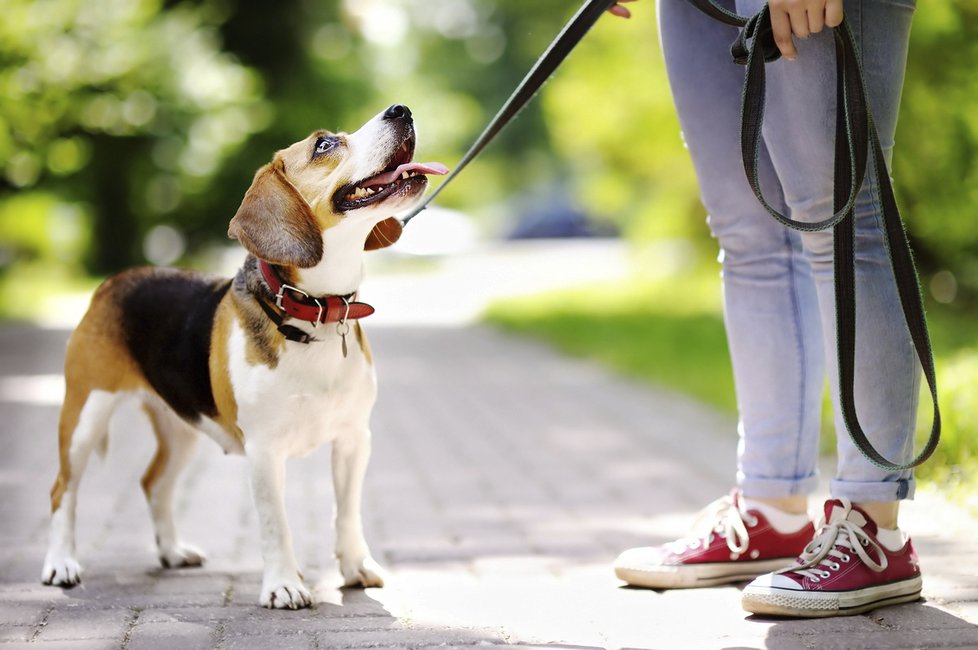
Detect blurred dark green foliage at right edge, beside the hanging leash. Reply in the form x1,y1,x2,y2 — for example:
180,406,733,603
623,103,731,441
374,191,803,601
893,0,978,304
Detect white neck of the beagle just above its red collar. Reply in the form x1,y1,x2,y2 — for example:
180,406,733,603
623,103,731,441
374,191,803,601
288,222,374,296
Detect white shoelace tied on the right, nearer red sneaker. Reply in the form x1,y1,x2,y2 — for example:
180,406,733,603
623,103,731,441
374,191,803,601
779,499,888,582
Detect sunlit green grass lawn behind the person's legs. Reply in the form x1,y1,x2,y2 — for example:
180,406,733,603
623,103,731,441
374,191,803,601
486,266,978,512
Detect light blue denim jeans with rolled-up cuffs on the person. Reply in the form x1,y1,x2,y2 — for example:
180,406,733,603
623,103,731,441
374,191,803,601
658,0,920,501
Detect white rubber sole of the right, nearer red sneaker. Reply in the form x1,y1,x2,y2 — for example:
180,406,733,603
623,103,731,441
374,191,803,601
741,576,923,618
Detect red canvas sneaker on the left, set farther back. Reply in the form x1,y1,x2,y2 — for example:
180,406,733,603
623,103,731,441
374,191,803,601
614,490,815,589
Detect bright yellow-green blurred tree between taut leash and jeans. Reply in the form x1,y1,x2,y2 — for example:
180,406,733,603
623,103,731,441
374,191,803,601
543,6,714,246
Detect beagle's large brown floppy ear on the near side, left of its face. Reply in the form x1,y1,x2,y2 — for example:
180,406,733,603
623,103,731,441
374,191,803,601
228,159,323,268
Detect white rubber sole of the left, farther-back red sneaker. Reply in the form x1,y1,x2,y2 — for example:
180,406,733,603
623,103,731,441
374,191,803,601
615,557,795,589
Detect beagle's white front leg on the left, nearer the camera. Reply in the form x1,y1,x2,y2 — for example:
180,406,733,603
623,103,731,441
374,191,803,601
246,447,312,609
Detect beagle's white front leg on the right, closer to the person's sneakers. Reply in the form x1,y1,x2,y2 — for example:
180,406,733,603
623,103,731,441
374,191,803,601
332,429,384,587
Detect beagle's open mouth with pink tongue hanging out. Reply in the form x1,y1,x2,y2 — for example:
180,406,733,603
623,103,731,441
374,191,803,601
334,138,448,212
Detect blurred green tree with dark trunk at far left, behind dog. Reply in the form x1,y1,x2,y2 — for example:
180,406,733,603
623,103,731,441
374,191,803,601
0,0,270,273
